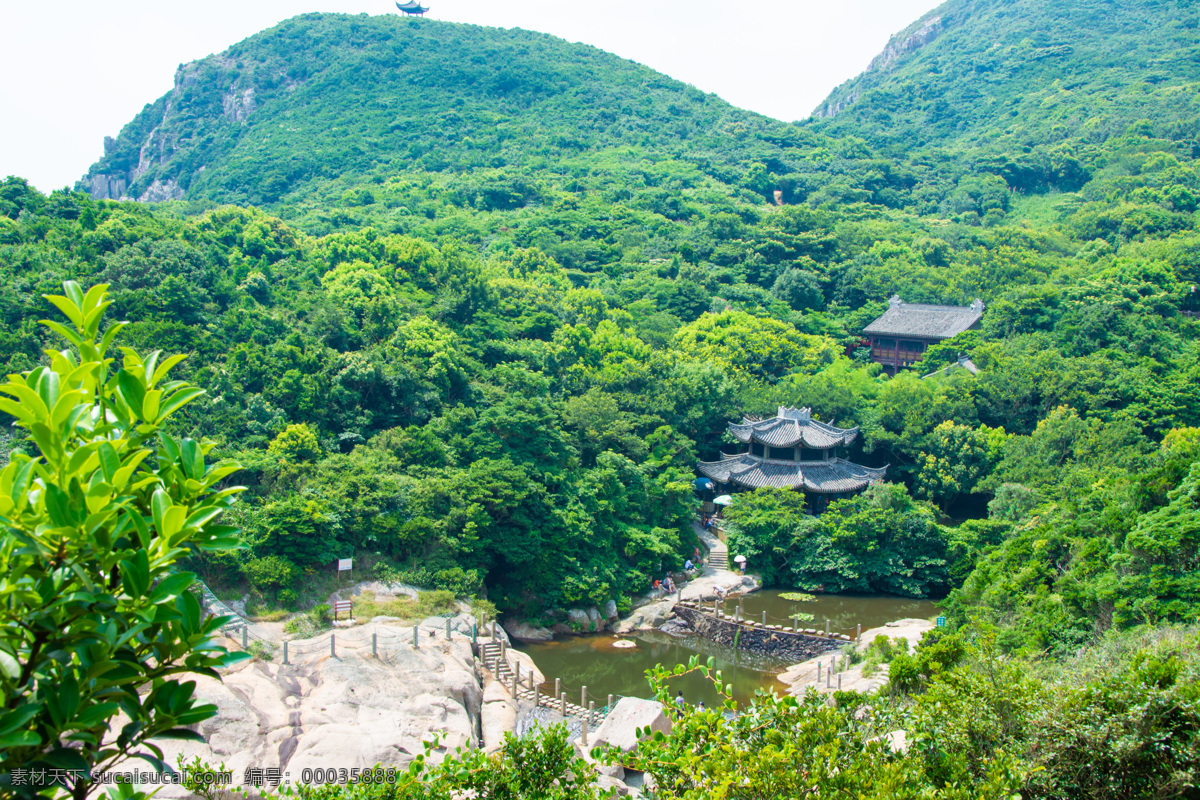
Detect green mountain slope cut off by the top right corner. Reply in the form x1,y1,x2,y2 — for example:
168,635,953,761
814,0,1200,164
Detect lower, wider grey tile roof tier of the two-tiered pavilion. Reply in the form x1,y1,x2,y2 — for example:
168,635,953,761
697,453,887,494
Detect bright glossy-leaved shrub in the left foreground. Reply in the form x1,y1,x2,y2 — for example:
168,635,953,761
0,281,246,800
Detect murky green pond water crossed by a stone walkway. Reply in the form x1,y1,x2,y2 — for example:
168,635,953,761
516,590,937,706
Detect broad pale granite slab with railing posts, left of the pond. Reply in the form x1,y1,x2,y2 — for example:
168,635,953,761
156,620,482,798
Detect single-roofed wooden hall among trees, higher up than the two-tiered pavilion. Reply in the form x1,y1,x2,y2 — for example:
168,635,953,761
863,295,983,375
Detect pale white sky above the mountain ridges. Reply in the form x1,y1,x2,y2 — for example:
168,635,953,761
0,0,937,191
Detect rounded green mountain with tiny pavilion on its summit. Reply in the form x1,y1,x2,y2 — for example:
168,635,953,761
82,14,820,209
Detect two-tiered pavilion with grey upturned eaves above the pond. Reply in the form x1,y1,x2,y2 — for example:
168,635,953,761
697,407,887,510
